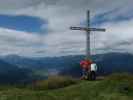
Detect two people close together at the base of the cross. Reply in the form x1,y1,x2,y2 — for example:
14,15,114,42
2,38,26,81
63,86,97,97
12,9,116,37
80,59,97,80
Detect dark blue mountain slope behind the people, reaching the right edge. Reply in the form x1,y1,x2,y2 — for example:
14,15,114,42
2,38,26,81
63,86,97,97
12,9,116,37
60,53,133,77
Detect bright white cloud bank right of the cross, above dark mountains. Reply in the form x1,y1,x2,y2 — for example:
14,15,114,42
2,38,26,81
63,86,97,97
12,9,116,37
93,19,133,53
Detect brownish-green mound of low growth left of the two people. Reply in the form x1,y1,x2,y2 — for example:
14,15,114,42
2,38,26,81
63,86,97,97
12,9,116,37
32,76,78,90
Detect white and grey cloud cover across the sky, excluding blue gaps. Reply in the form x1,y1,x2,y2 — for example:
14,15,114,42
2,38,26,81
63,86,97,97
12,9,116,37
0,0,133,56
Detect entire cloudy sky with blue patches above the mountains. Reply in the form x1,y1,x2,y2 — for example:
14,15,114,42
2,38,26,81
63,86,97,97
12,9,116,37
0,0,133,57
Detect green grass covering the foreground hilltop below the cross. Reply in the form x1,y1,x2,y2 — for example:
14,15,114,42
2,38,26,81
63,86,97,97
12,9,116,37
0,74,133,100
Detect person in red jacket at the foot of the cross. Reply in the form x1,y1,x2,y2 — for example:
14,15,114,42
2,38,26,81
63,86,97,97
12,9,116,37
80,60,93,79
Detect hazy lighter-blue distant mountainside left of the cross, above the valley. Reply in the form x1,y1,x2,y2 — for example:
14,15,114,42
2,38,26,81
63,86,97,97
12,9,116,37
1,55,83,69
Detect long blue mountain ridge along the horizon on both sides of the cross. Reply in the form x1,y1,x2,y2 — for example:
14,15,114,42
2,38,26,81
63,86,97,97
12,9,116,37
1,53,133,76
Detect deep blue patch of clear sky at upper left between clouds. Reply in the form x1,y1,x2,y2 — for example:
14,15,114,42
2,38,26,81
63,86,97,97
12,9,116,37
0,15,48,33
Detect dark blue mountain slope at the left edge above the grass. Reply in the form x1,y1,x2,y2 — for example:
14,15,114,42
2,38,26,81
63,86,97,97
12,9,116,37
0,60,29,84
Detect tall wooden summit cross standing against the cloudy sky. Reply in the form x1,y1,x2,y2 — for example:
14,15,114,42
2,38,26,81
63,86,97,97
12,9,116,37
70,10,106,59
